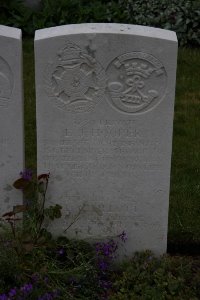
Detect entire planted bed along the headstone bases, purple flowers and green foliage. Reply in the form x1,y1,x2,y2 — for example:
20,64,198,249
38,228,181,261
0,170,200,300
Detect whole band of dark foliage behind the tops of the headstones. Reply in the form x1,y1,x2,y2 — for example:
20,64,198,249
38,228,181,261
0,0,200,46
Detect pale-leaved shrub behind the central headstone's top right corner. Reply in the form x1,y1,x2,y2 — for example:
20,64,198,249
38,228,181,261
120,0,200,46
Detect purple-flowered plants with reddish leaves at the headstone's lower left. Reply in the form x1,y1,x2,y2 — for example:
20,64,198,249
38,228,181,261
0,170,126,300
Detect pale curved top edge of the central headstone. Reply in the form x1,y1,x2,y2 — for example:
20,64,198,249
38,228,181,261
35,23,177,42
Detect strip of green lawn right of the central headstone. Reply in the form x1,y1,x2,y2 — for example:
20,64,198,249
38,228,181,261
168,49,200,245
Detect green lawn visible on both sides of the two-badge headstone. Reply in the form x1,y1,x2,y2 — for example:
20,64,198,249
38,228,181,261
24,39,200,246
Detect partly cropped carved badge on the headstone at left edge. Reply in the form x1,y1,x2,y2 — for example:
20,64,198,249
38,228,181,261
0,57,13,107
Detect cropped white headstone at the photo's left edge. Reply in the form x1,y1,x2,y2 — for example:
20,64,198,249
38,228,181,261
0,25,24,215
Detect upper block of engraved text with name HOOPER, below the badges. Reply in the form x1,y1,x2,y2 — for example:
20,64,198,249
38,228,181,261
43,120,163,181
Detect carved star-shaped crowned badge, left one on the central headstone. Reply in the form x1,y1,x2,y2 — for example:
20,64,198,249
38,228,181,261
45,42,106,113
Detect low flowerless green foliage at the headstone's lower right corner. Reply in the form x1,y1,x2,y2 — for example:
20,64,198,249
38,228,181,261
109,251,200,300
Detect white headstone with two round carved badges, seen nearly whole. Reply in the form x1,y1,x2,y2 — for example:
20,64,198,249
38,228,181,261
35,24,177,255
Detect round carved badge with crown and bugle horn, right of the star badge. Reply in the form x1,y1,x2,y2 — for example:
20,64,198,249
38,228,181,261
107,52,167,113
